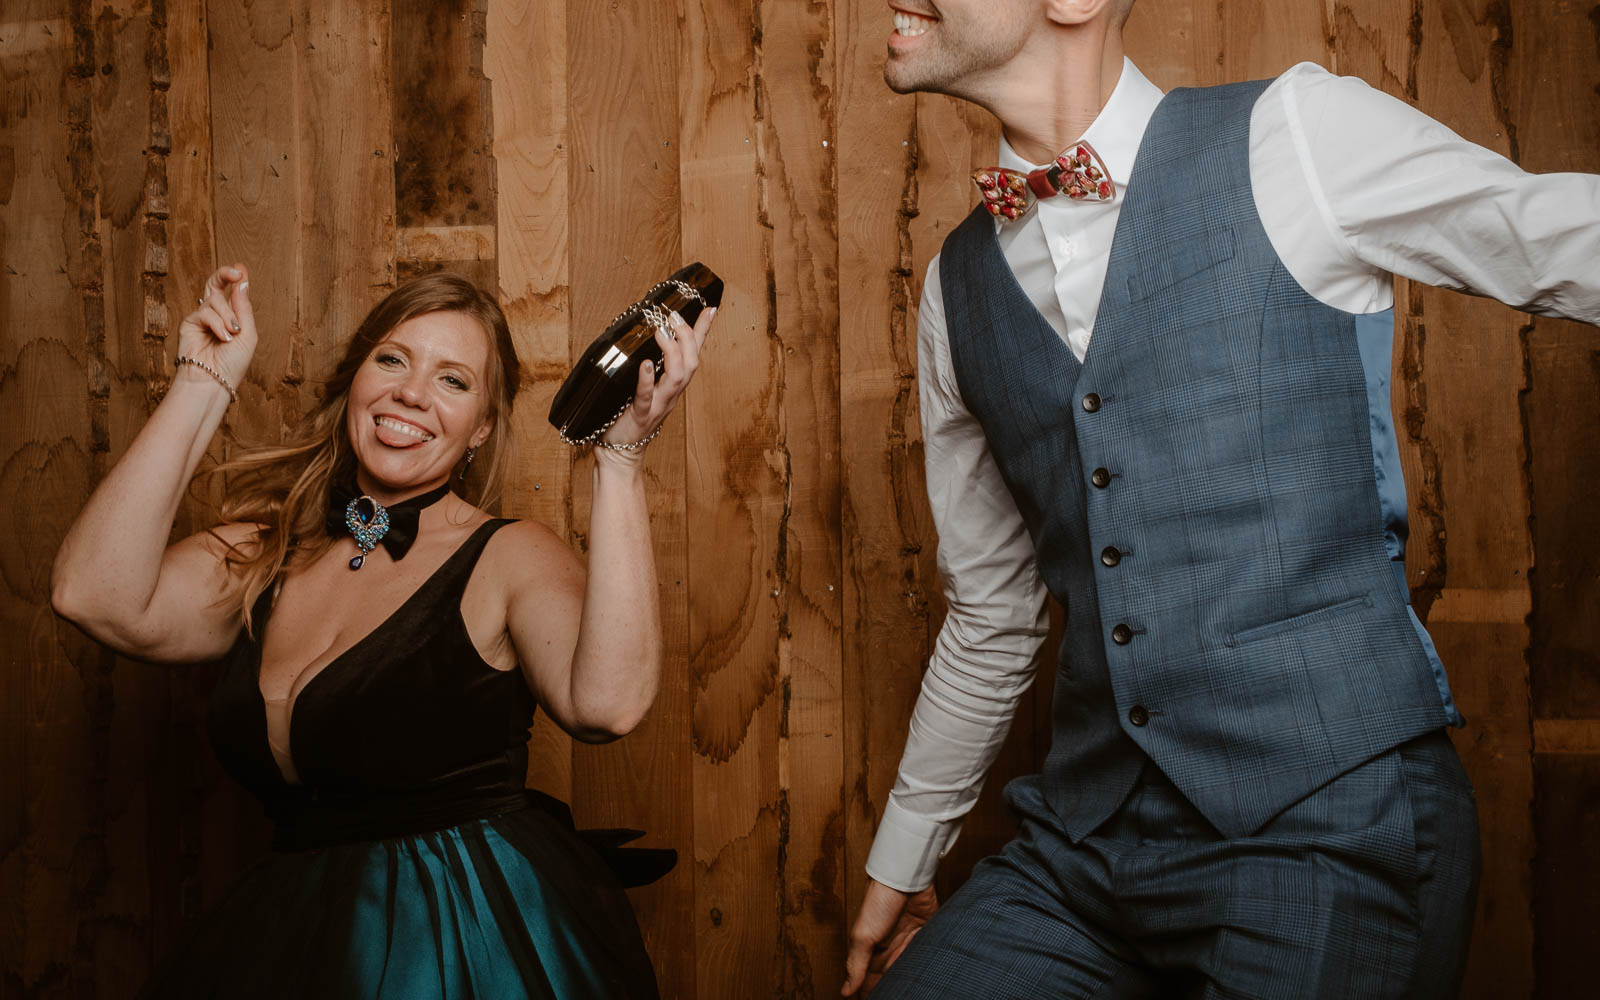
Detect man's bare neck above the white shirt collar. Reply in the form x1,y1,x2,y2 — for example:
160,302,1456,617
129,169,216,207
989,32,1123,163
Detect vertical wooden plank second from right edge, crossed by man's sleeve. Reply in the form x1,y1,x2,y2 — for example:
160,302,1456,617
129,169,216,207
1390,0,1533,998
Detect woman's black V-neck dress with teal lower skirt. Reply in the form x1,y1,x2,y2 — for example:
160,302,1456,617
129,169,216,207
146,520,656,1000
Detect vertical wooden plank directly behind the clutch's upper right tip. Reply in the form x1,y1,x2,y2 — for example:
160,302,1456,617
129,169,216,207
678,3,777,994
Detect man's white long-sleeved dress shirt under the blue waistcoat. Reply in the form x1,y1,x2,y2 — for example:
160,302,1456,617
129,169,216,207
867,61,1600,891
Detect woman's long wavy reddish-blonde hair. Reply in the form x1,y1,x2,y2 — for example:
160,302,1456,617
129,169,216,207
210,272,522,632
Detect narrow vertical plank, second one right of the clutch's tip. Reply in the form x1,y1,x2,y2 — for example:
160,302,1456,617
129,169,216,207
748,2,848,997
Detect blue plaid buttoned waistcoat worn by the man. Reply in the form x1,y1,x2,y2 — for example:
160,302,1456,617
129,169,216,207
939,82,1458,840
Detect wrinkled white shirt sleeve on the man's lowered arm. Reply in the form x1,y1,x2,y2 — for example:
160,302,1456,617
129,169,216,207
867,258,1050,891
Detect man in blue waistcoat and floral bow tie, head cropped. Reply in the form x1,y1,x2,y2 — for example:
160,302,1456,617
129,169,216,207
843,0,1600,1000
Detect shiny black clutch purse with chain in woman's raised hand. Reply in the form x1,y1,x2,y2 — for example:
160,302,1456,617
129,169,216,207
550,261,722,445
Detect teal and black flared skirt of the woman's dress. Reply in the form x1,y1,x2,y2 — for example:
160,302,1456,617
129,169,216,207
142,808,656,1000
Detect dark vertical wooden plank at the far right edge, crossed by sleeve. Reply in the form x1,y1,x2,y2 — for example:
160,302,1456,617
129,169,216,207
1506,3,1600,997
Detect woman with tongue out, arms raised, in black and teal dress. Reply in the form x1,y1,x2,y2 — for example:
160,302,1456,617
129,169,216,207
53,266,714,998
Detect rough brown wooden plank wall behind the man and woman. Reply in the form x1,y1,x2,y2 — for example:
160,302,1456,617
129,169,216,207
0,0,1600,998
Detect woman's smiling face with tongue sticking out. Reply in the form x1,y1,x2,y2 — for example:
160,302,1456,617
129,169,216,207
346,312,494,504
